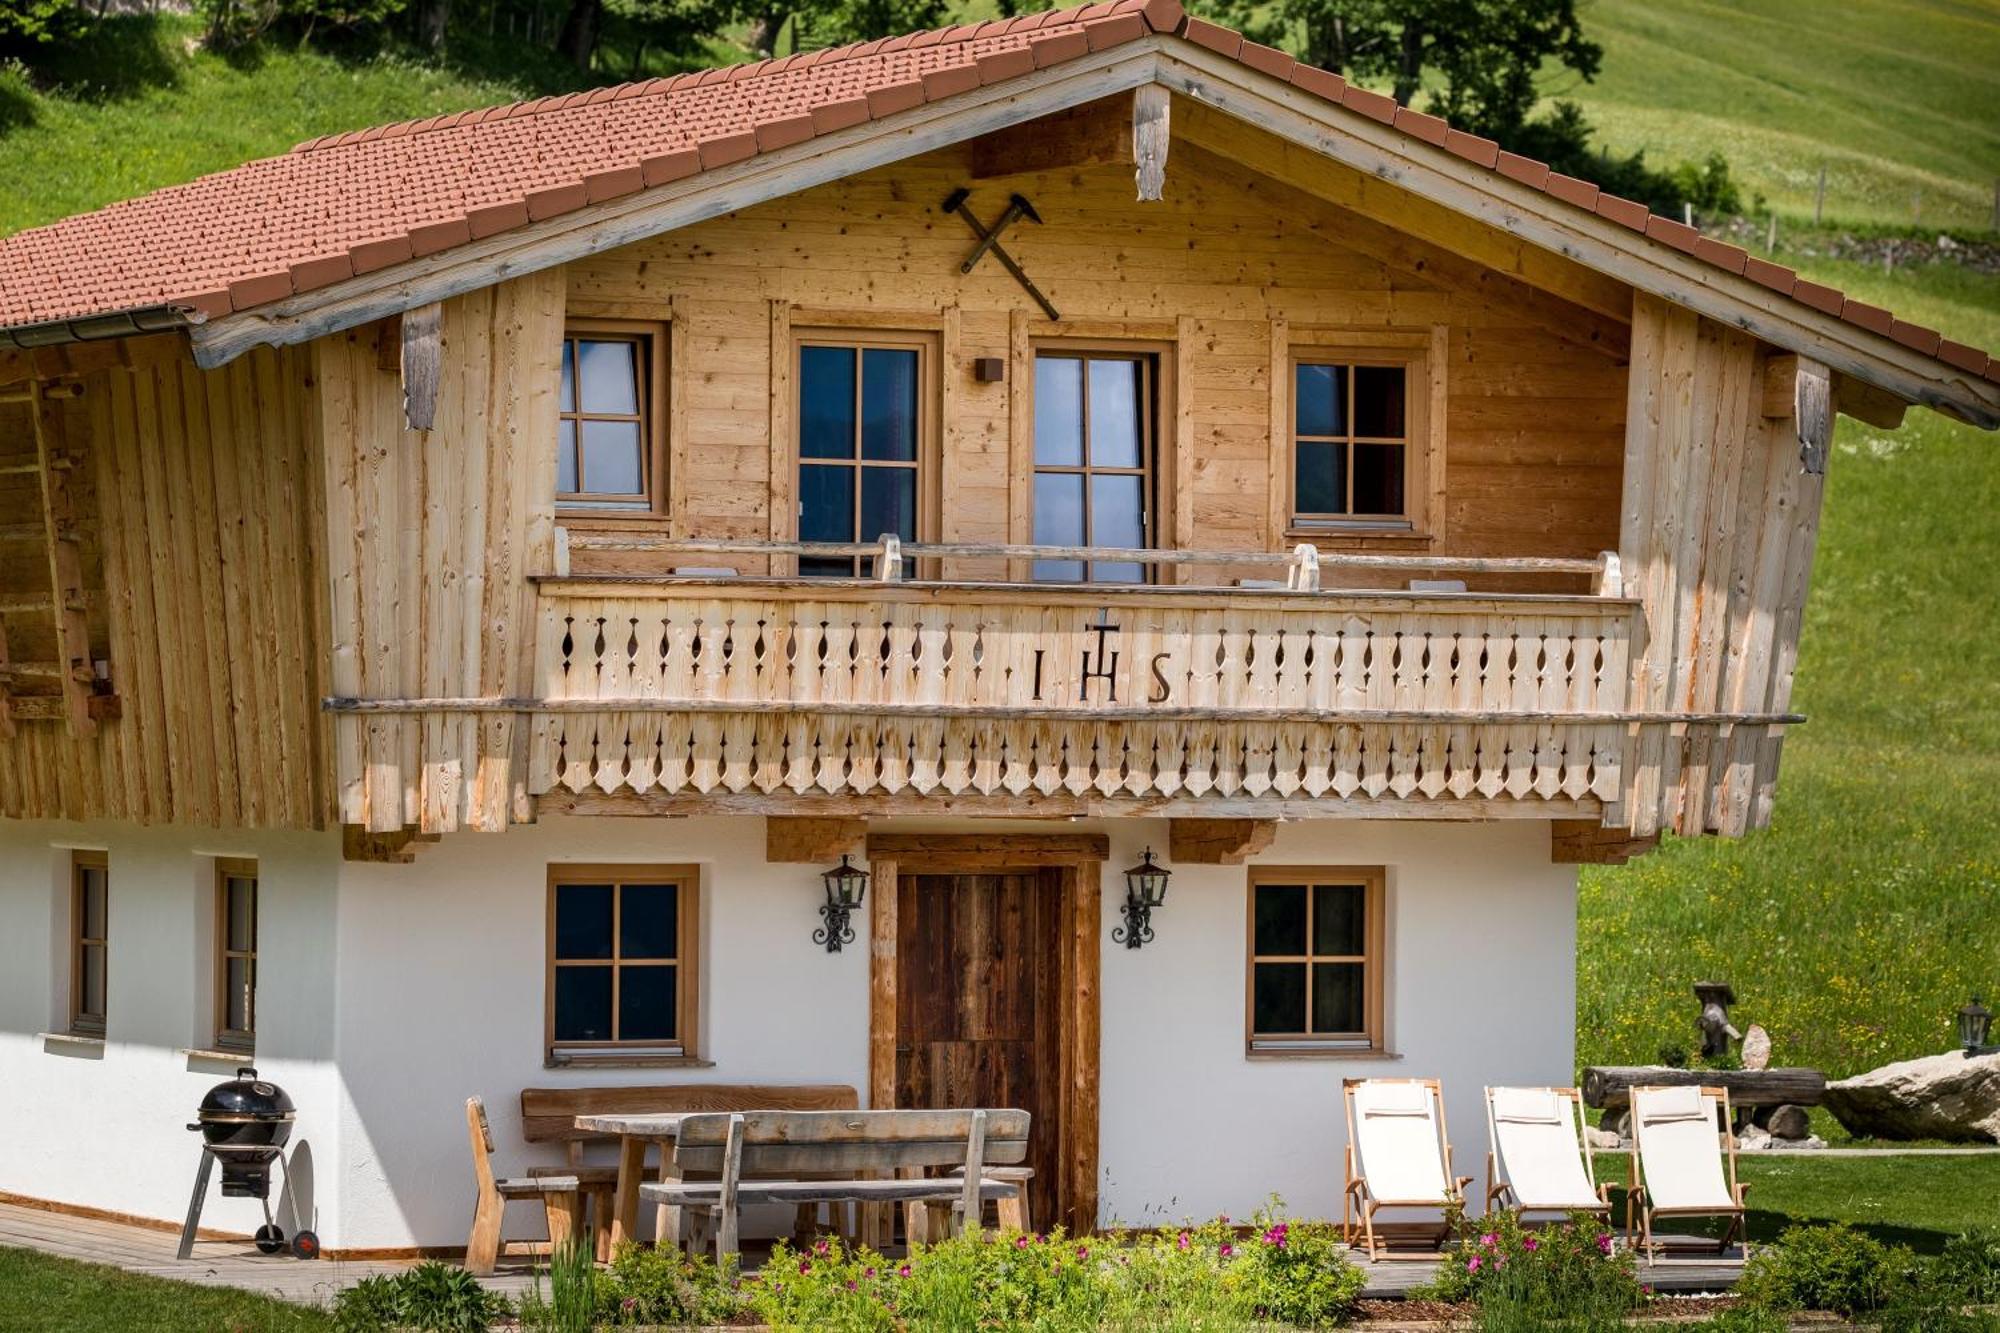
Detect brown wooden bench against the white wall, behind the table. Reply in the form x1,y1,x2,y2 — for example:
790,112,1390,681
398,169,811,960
520,1083,860,1263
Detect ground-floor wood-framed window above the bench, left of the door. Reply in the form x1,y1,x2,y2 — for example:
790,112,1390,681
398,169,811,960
546,865,700,1065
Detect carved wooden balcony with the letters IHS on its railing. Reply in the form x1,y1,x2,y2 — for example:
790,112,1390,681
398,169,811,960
526,534,1664,819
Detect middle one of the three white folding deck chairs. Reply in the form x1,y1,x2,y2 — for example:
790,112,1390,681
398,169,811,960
1486,1087,1612,1221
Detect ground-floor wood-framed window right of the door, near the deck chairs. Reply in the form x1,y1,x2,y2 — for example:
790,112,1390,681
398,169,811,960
1244,867,1386,1055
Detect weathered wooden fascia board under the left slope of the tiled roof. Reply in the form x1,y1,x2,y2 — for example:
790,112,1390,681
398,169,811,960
190,45,1164,368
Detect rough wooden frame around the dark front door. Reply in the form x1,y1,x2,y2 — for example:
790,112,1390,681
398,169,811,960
868,833,1110,1235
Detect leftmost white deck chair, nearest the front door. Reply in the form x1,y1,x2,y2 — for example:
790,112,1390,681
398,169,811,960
1340,1079,1472,1263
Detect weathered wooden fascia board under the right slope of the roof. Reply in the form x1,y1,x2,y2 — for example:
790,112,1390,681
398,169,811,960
1158,42,2000,430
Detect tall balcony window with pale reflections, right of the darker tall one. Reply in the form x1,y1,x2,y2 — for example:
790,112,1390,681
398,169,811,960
1032,346,1160,582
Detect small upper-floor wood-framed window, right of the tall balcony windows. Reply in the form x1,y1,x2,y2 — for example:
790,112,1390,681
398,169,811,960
1288,336,1438,536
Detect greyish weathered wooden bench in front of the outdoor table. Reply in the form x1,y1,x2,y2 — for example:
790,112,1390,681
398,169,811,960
640,1109,1030,1263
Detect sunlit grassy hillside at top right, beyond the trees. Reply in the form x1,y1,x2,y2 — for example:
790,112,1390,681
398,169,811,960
1556,0,2000,228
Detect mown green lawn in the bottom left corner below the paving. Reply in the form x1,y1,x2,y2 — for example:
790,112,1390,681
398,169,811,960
0,1249,334,1333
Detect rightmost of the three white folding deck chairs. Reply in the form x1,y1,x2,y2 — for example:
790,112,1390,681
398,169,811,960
1626,1087,1748,1263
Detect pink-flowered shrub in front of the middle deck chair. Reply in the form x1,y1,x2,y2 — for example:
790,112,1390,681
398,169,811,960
1430,1213,1642,1327
